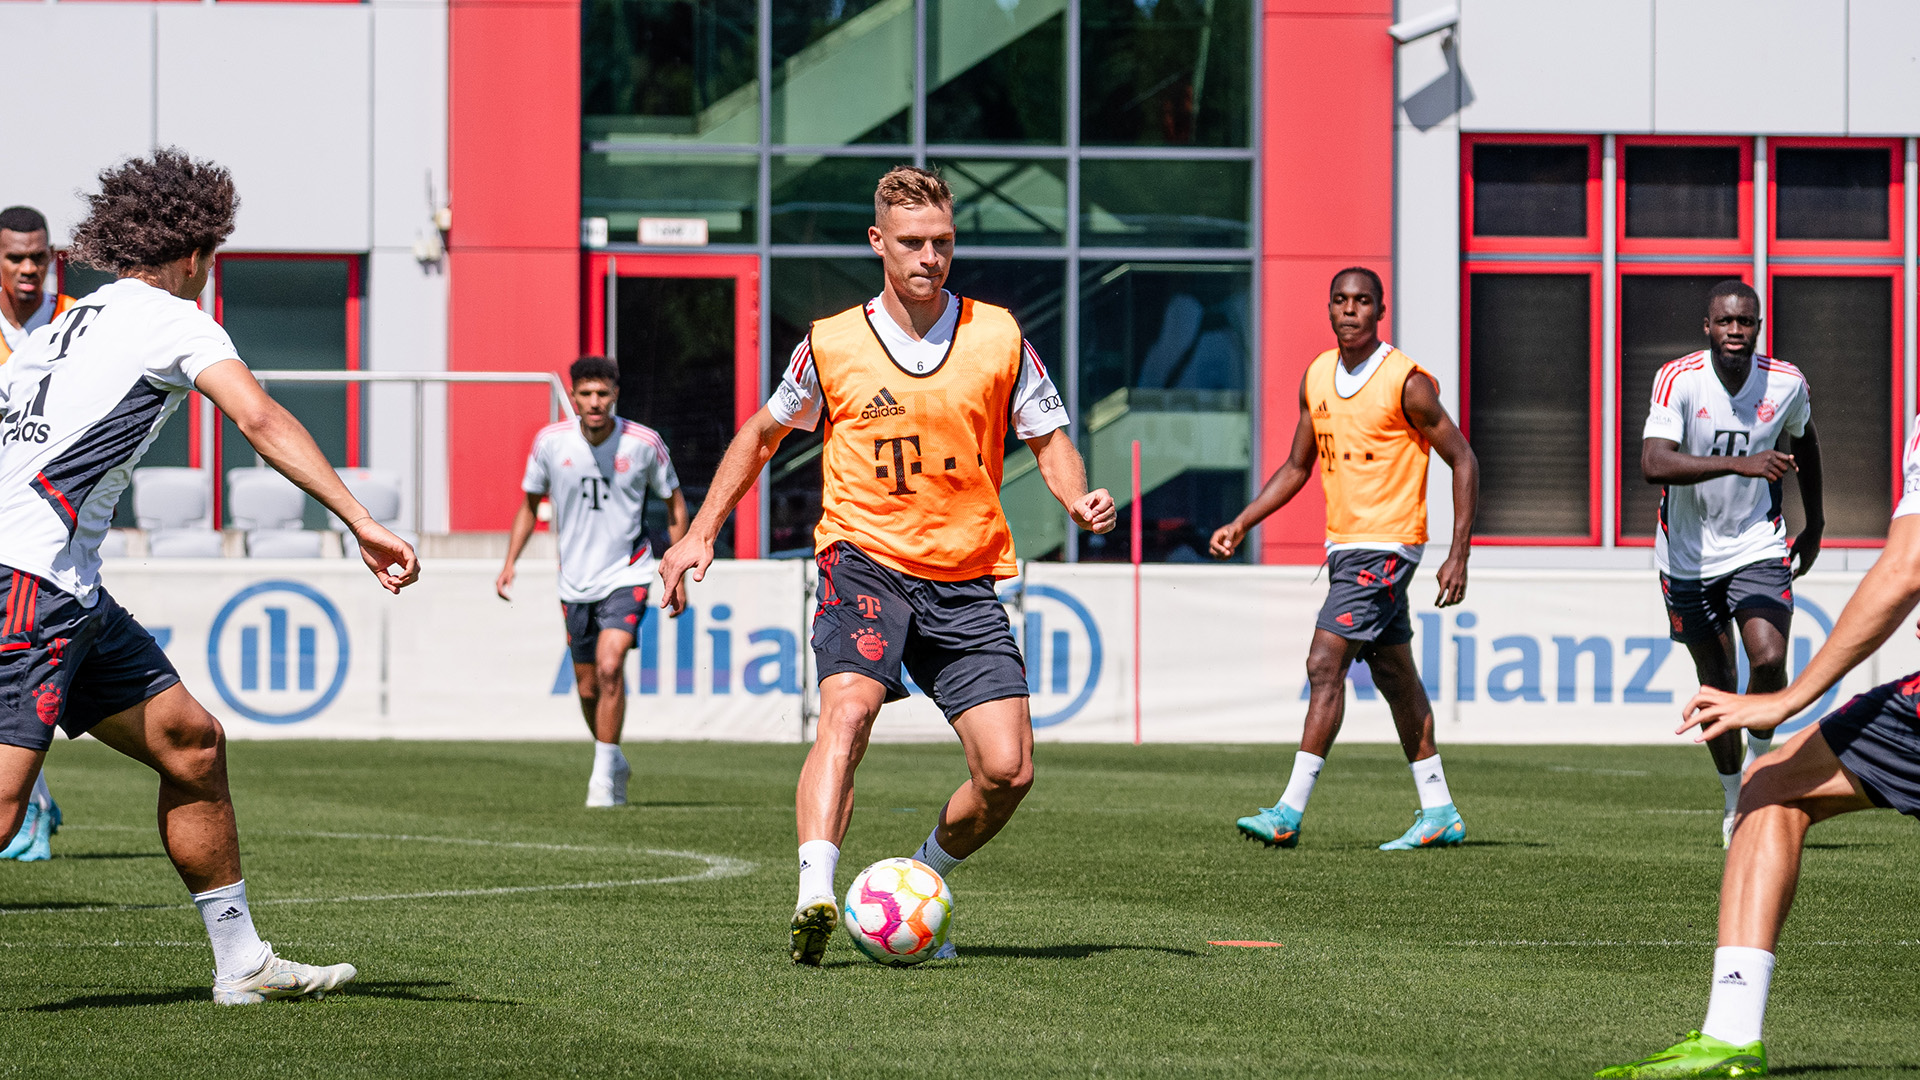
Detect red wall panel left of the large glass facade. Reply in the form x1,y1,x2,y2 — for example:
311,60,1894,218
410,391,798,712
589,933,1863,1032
447,0,580,530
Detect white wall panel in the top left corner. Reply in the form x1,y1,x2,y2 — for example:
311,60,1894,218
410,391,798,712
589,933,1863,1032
0,4,154,246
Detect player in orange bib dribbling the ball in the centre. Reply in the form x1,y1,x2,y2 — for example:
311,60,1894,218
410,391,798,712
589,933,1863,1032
660,165,1116,965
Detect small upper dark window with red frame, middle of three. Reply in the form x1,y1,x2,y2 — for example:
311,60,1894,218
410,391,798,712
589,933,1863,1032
1626,146,1740,240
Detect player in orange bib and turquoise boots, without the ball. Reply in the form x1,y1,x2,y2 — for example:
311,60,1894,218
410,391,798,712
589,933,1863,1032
1212,267,1480,851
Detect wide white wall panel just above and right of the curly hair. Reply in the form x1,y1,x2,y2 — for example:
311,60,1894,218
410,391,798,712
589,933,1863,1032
156,4,372,252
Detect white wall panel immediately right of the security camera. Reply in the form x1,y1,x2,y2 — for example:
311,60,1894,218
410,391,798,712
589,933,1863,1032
1459,0,1653,133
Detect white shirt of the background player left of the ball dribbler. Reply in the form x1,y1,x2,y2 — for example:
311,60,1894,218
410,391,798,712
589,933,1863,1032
520,419,680,603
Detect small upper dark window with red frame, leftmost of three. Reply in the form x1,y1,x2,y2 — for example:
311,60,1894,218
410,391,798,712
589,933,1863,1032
1473,142,1592,236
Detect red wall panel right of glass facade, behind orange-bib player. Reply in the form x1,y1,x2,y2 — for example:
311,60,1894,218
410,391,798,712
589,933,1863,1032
1258,0,1394,563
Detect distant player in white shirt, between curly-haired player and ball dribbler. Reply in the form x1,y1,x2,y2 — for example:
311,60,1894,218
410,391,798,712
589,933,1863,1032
493,356,687,807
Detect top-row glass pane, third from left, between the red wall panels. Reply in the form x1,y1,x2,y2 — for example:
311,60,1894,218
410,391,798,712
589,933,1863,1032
927,0,1066,146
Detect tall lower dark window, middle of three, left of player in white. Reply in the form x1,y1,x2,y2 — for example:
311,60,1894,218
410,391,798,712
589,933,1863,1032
1620,275,1736,536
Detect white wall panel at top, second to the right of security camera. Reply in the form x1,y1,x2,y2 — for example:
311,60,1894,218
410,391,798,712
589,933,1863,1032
1653,0,1847,135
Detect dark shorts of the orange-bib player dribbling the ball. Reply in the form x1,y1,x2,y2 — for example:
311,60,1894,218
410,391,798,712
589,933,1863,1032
812,540,1027,721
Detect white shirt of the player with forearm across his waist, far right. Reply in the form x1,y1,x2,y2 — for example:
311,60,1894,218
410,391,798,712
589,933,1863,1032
1644,350,1812,578
